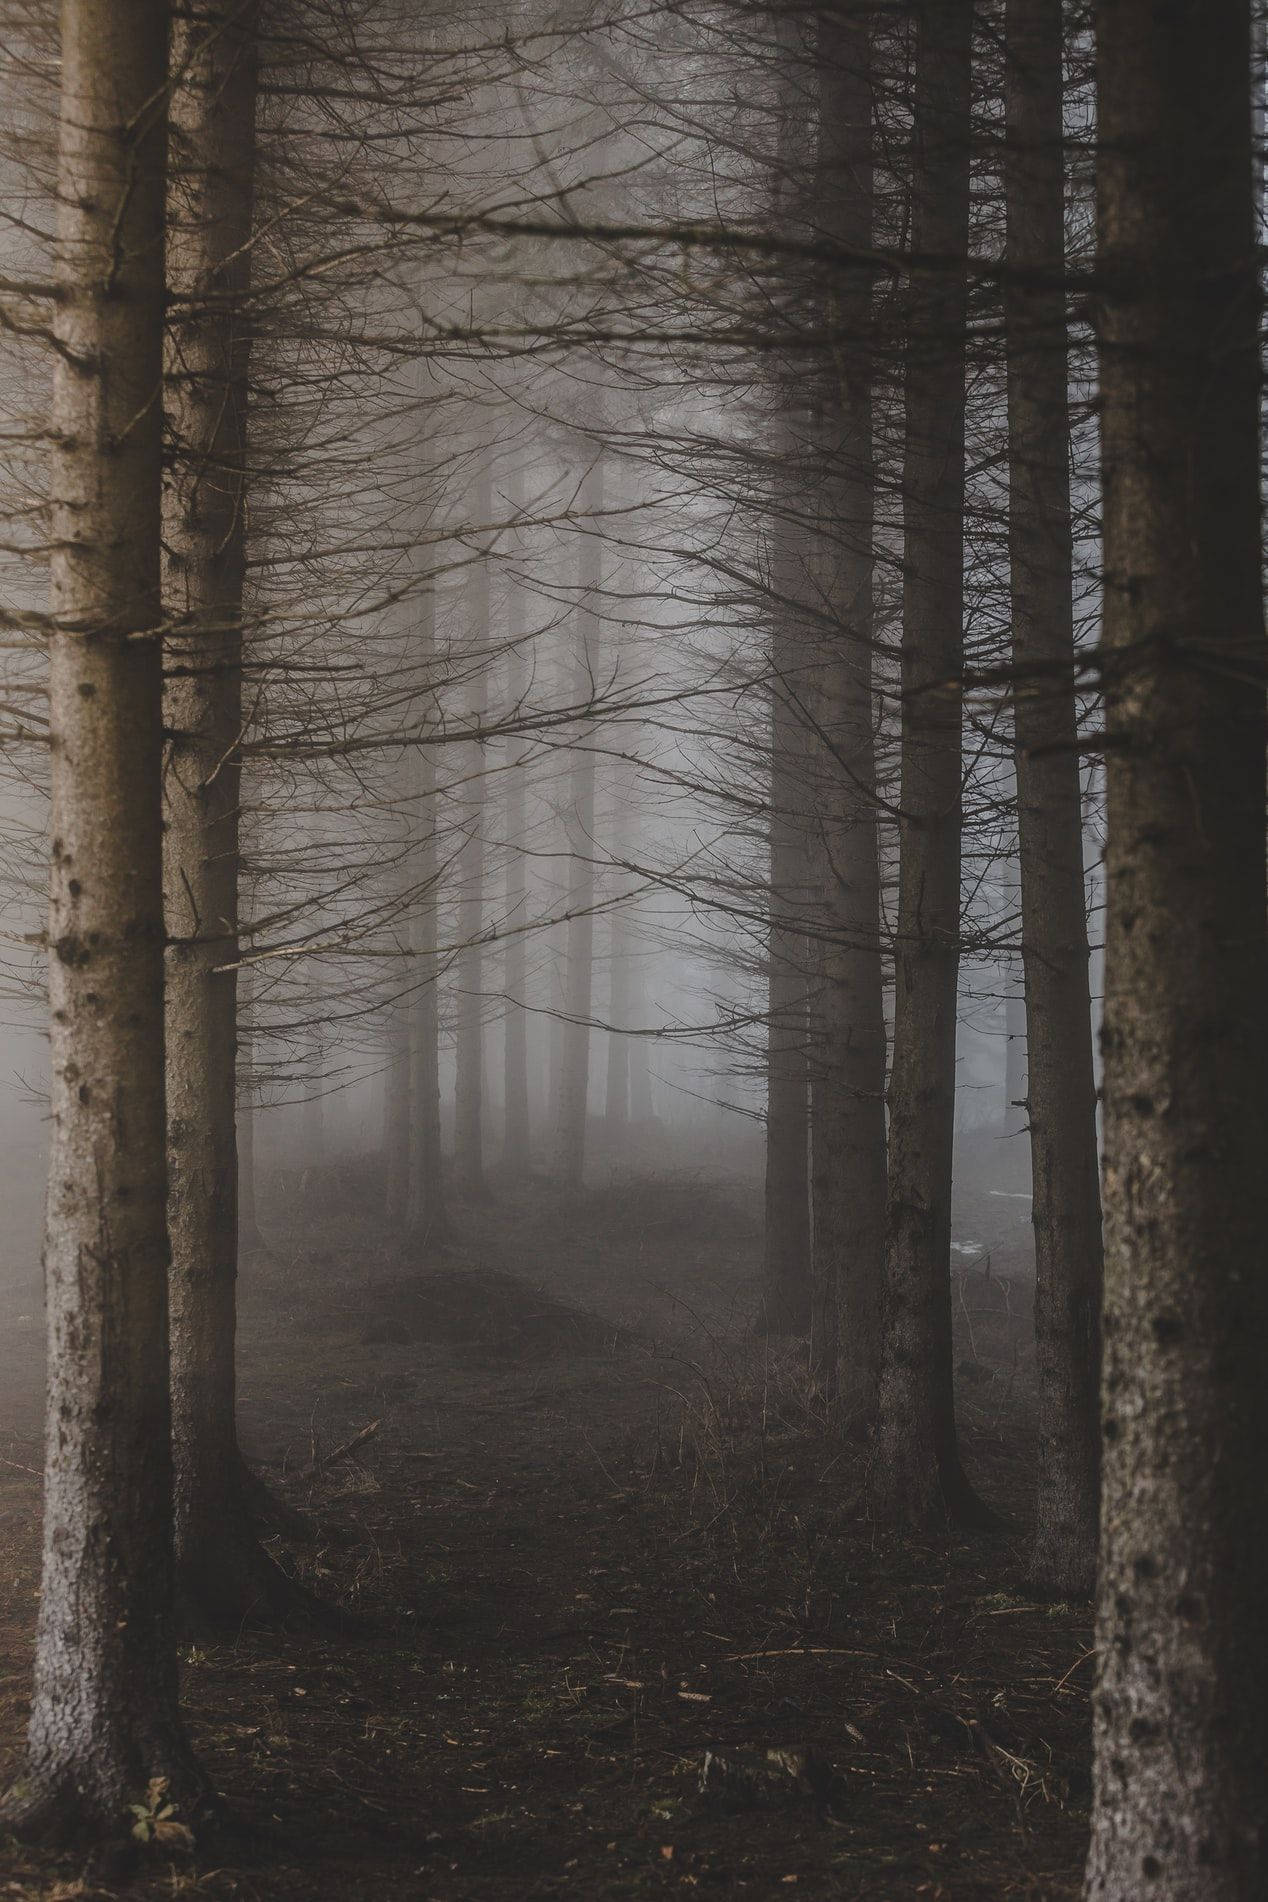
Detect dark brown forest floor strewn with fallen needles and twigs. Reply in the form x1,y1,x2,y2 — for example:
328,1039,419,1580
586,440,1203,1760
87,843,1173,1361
0,1141,1091,1902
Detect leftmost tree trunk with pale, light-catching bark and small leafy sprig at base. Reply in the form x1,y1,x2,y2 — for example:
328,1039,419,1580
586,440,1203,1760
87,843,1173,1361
0,0,203,1835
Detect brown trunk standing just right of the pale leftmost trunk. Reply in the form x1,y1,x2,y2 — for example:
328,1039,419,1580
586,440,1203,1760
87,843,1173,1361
163,0,287,1622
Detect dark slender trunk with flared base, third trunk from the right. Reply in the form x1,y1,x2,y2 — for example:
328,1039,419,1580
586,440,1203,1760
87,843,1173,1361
873,0,973,1525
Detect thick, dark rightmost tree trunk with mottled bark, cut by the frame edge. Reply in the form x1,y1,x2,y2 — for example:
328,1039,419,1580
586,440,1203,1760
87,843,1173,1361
1087,0,1268,1902
